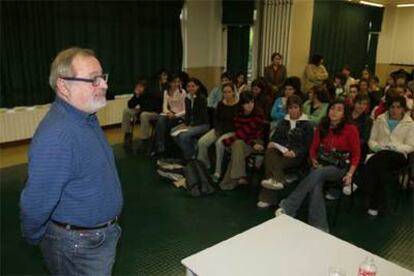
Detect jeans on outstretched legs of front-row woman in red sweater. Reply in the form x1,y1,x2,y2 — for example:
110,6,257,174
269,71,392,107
279,166,346,232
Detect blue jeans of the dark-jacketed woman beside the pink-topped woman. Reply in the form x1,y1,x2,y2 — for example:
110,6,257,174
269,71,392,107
174,124,209,160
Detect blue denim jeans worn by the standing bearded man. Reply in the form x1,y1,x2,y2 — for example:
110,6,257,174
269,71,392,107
40,222,121,275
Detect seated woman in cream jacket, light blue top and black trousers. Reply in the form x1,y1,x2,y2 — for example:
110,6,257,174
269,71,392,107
361,96,414,216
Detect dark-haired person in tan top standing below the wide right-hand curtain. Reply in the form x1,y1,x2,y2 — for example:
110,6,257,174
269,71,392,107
303,54,329,94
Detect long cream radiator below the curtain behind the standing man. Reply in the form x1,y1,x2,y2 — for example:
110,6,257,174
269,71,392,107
0,94,131,143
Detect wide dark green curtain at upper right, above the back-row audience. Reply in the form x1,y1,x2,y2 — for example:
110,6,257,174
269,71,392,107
310,0,383,77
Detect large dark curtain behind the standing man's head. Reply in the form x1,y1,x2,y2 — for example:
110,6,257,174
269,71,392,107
0,1,183,107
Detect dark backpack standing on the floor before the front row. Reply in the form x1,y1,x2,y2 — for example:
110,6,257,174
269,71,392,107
184,160,214,197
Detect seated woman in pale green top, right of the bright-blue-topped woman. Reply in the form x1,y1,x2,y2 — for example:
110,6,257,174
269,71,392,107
303,86,329,127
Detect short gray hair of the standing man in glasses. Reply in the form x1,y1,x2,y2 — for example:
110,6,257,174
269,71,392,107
49,47,95,91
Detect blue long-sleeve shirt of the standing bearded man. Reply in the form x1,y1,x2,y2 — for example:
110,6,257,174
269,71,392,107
20,97,123,244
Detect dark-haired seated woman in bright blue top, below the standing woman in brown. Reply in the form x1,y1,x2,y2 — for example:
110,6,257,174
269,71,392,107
270,77,301,122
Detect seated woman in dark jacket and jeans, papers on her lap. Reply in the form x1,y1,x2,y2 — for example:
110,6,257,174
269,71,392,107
171,78,209,160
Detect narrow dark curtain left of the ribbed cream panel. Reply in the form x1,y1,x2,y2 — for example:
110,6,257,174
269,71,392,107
227,26,250,74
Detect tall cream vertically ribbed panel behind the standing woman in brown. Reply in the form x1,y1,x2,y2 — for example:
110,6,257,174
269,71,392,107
258,0,293,76
